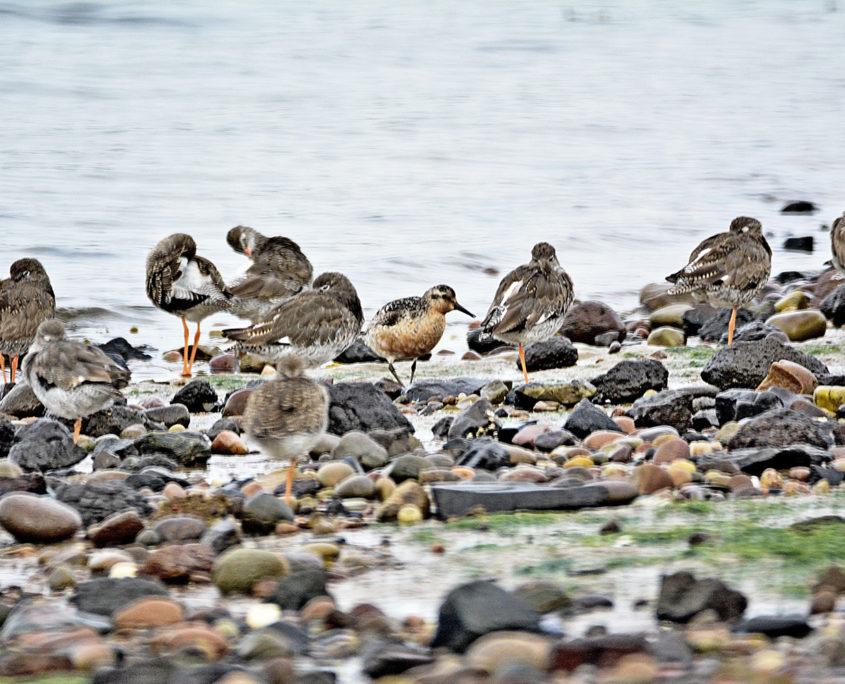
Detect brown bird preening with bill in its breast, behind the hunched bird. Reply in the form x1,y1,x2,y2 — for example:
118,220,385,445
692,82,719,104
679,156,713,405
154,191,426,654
226,226,314,323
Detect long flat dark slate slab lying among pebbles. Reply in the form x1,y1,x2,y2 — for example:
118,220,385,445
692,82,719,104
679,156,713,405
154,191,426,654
431,482,636,519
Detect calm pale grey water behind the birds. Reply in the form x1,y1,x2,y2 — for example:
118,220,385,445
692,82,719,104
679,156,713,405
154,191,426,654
0,0,845,368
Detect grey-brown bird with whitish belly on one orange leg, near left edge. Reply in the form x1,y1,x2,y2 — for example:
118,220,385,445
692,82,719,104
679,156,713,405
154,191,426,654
22,319,129,444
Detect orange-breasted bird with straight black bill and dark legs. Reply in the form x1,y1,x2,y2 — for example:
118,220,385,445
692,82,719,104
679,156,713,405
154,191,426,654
365,285,473,385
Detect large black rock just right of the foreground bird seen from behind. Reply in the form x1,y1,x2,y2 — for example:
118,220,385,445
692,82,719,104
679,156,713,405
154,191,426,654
329,382,414,435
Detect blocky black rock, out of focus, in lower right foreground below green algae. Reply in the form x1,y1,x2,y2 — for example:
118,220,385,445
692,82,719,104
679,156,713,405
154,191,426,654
657,572,748,622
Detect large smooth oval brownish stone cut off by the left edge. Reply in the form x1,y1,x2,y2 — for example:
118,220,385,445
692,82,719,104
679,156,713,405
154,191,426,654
0,492,82,544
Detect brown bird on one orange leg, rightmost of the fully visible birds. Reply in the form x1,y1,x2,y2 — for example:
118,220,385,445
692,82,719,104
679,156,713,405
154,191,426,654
666,216,772,345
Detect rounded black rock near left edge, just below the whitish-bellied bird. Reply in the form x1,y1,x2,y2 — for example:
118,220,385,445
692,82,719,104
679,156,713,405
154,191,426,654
9,418,88,472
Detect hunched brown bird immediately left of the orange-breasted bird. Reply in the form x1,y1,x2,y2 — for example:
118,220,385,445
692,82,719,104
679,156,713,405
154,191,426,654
223,273,364,367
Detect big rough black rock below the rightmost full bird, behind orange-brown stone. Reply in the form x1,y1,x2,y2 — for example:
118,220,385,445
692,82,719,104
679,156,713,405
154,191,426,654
701,337,829,389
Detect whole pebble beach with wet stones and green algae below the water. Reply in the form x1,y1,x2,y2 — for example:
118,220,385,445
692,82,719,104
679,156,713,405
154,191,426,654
6,260,845,683
